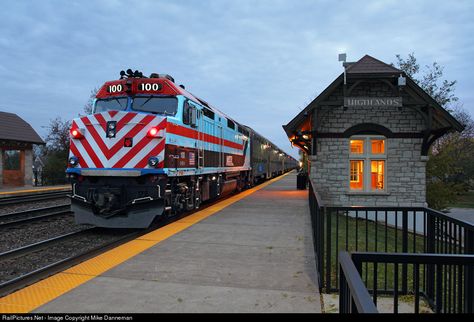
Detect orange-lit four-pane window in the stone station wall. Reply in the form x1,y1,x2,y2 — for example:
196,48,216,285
349,136,387,192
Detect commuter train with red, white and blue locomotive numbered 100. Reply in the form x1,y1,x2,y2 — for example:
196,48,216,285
67,69,297,228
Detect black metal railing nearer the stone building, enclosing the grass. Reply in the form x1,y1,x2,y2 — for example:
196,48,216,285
309,181,474,312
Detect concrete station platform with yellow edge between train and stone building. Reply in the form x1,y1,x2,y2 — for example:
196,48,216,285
0,172,321,313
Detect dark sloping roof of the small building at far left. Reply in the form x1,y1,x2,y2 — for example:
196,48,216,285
0,112,45,144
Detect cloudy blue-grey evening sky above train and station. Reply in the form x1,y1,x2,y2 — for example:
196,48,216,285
0,0,474,156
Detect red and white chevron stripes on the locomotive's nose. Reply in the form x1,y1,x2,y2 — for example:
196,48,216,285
69,111,166,169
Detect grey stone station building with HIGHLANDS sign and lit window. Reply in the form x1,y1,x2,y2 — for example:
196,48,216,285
283,55,463,207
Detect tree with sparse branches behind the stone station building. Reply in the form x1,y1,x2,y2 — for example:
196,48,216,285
396,53,474,209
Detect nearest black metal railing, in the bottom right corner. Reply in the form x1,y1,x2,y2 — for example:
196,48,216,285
339,252,474,313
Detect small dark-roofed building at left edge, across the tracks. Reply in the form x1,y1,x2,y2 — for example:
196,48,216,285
0,112,45,188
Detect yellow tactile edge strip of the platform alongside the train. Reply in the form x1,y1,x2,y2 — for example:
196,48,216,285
0,173,288,313
